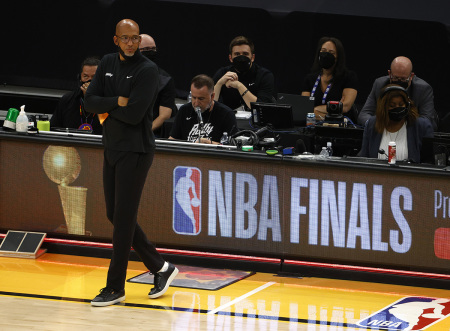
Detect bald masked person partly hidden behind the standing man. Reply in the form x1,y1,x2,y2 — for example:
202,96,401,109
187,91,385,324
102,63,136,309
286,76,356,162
139,34,177,137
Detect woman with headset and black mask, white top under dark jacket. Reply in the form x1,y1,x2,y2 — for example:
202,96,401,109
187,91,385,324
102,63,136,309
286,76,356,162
359,84,433,163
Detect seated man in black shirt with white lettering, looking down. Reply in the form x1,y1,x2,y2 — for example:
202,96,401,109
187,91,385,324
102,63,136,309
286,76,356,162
169,75,237,144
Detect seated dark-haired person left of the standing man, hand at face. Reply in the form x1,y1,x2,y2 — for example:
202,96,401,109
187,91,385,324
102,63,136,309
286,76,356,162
50,57,102,135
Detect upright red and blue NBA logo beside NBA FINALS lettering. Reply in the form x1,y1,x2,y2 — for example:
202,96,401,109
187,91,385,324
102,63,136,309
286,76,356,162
172,167,202,235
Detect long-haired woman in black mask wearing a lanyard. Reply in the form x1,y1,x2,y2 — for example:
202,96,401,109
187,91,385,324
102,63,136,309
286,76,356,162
302,37,358,121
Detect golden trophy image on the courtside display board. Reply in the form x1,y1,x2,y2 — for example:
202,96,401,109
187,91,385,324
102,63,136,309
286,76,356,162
43,146,87,235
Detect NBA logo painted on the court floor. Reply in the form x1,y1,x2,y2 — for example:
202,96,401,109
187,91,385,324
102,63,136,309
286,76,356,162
357,297,450,331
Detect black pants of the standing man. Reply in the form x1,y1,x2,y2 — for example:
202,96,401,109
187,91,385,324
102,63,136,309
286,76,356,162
103,148,164,291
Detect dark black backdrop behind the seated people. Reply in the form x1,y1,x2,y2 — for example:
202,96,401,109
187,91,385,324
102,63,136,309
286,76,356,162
0,0,450,130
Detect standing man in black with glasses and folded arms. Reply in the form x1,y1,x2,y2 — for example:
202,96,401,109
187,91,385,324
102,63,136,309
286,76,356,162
85,19,178,306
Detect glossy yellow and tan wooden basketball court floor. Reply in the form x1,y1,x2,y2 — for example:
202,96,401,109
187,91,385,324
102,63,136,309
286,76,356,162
0,253,450,331
